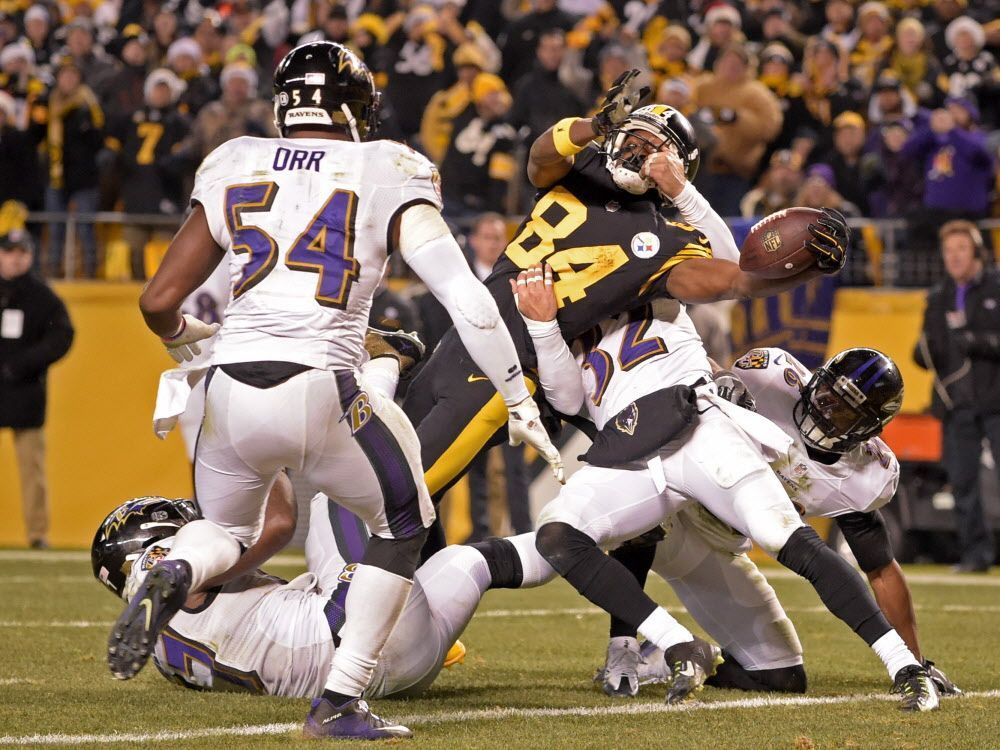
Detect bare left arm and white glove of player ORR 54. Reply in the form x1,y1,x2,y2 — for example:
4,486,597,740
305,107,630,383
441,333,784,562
139,204,223,362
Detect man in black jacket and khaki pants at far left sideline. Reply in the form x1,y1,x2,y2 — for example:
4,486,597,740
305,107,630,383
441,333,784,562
0,230,73,549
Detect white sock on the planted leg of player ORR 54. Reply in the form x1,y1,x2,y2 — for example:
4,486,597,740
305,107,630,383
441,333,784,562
325,565,413,696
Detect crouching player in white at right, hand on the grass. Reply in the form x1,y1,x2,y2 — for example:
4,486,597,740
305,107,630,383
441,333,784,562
598,349,960,696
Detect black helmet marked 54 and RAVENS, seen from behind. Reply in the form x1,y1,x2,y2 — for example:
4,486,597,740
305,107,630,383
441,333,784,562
274,41,381,141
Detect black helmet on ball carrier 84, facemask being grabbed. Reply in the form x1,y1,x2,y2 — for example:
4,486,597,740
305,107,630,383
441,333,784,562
604,104,701,195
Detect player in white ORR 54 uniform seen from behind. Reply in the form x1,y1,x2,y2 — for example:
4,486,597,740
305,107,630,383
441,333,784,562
115,42,560,739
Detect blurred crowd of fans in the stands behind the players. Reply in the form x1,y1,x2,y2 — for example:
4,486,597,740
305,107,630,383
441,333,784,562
0,0,1000,278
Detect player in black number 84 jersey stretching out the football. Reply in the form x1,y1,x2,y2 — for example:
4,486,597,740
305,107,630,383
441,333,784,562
403,71,847,553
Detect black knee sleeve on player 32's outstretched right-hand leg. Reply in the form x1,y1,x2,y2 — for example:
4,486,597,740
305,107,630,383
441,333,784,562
778,526,892,646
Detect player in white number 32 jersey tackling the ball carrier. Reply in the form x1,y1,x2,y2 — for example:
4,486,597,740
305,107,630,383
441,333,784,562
513,268,938,711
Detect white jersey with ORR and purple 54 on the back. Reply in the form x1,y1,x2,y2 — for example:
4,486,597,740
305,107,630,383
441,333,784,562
191,137,441,369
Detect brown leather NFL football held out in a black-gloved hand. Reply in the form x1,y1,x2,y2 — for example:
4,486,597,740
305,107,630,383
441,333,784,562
740,208,823,279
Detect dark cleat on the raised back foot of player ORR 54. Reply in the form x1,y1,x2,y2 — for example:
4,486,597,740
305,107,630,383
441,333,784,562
108,560,191,680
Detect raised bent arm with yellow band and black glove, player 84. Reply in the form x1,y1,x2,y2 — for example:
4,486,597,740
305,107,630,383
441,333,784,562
528,68,649,188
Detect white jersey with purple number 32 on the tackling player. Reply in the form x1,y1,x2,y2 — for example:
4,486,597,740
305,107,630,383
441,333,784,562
573,299,712,429
